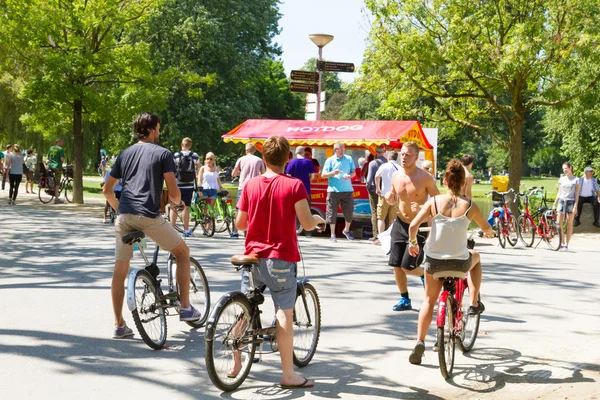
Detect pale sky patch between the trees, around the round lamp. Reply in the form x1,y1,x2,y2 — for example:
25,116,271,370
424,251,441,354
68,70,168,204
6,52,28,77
275,0,369,82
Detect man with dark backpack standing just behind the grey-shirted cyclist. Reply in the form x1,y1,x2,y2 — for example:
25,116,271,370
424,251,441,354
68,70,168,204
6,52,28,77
169,137,200,237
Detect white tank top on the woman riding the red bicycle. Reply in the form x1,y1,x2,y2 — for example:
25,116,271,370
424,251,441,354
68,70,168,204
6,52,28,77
424,198,472,260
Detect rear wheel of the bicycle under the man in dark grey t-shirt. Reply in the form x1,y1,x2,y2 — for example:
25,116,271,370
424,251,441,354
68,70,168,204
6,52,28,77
131,270,167,350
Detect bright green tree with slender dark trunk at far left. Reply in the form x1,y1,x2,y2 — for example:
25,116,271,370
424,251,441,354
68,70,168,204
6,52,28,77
0,0,166,203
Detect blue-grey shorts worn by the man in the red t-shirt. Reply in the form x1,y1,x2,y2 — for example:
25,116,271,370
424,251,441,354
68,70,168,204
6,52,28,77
241,258,297,310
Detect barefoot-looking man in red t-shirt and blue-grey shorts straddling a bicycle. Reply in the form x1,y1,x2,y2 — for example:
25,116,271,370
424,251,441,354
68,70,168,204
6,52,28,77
236,136,325,388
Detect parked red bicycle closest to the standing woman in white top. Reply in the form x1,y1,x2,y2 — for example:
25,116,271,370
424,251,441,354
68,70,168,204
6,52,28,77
516,186,563,251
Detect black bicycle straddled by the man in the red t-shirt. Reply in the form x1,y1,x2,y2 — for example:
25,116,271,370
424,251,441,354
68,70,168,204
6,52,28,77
205,254,321,392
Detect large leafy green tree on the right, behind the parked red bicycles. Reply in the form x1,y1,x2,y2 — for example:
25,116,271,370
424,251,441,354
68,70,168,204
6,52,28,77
363,0,600,189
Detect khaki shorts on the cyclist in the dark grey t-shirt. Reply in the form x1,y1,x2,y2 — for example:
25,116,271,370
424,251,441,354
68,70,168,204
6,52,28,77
115,214,183,261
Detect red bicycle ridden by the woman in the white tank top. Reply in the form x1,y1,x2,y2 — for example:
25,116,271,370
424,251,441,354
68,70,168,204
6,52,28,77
433,271,481,379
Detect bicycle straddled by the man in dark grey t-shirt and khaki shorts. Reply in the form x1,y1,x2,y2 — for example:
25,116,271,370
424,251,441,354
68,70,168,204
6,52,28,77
121,231,210,350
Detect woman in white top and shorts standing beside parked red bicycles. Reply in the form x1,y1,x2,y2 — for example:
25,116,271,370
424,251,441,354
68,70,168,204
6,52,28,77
552,161,580,250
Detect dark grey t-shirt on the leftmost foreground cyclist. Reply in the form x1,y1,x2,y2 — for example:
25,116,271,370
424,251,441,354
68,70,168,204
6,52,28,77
110,142,175,218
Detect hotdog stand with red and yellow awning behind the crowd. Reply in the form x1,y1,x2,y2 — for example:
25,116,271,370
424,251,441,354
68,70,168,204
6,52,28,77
222,119,435,234
